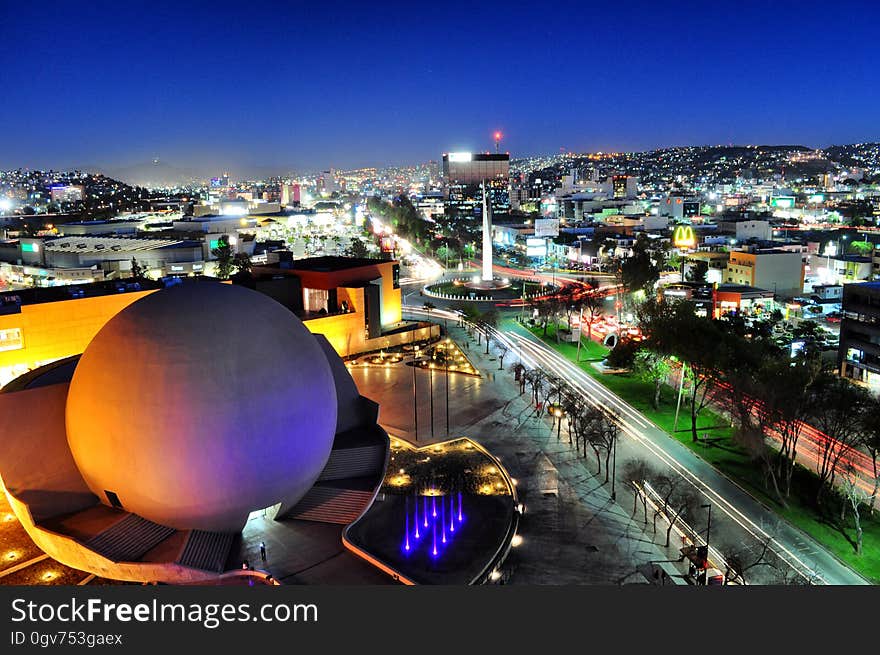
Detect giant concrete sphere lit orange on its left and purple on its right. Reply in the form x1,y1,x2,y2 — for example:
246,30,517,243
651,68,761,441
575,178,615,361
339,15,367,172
66,282,336,532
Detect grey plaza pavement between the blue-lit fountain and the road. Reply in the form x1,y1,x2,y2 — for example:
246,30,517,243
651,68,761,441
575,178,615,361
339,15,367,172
351,325,686,584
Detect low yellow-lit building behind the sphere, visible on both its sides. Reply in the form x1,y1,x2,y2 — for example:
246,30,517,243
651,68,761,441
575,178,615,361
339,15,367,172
0,257,439,385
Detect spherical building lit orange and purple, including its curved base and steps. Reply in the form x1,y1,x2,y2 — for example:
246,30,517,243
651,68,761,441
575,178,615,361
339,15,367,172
0,280,389,583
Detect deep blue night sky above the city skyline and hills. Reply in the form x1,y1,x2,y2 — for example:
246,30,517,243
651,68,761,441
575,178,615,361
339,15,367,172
0,0,880,172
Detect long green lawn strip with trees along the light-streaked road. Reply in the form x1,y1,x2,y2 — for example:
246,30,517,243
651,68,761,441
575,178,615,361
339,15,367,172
510,321,880,583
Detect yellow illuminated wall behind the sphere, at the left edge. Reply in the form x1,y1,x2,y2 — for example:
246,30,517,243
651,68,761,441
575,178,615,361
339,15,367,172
0,289,155,384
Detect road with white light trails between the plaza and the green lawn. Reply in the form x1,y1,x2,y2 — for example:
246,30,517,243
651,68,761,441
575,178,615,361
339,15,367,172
405,307,869,585
